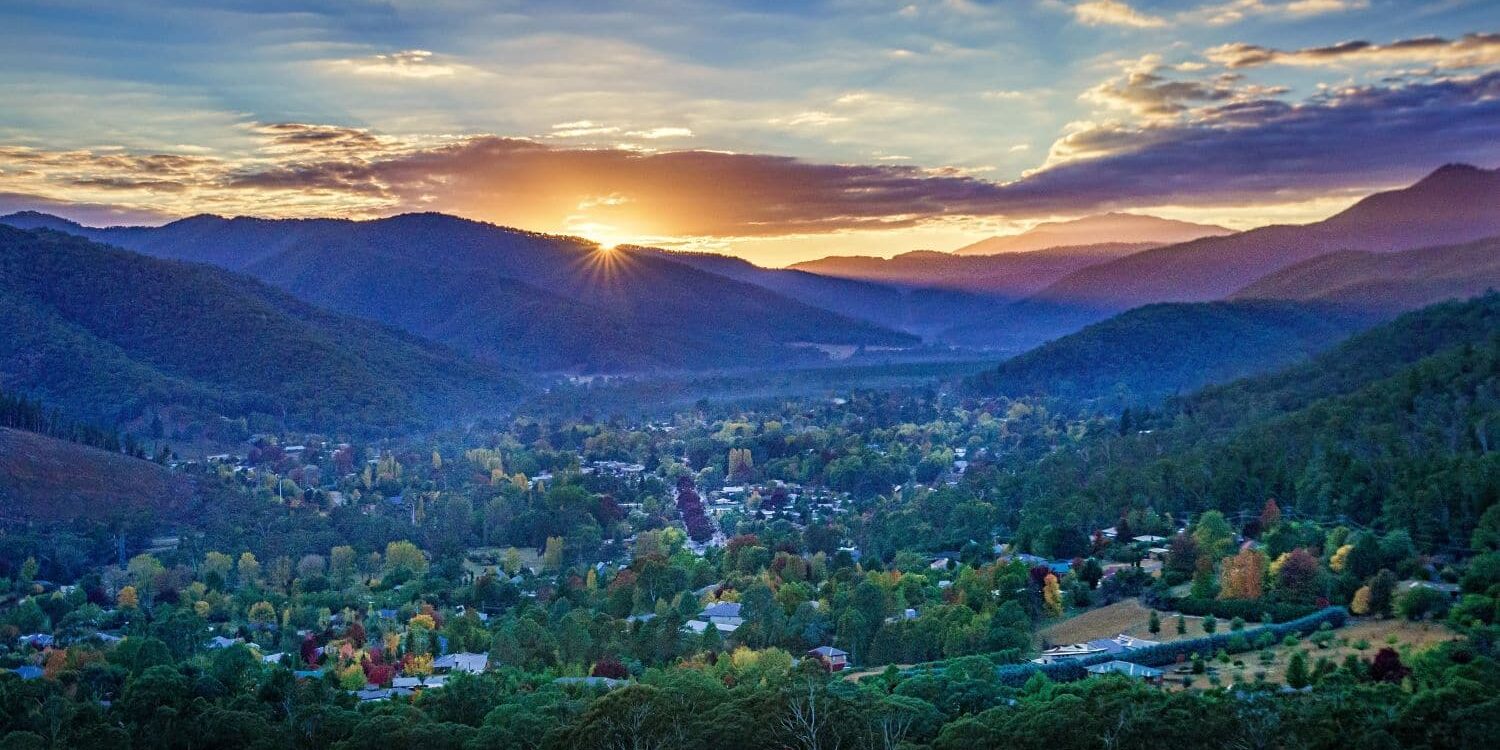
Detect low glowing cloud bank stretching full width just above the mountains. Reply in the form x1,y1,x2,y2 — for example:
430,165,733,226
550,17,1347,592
0,68,1500,240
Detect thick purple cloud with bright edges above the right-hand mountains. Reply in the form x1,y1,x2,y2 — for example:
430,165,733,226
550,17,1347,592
1032,74,1500,207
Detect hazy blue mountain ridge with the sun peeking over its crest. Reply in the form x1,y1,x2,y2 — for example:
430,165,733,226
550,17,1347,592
0,213,917,372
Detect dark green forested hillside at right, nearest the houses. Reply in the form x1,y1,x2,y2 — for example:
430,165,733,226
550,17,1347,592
1002,294,1500,549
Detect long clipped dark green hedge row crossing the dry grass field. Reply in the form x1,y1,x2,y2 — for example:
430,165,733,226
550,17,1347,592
908,608,1349,687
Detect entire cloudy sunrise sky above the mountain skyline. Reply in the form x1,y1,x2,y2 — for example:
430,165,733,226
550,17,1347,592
0,0,1500,266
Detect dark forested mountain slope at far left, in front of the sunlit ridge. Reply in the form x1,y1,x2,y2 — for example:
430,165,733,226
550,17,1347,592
0,227,527,440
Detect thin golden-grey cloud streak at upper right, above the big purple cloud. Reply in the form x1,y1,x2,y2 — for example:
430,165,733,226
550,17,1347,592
1206,33,1500,69
